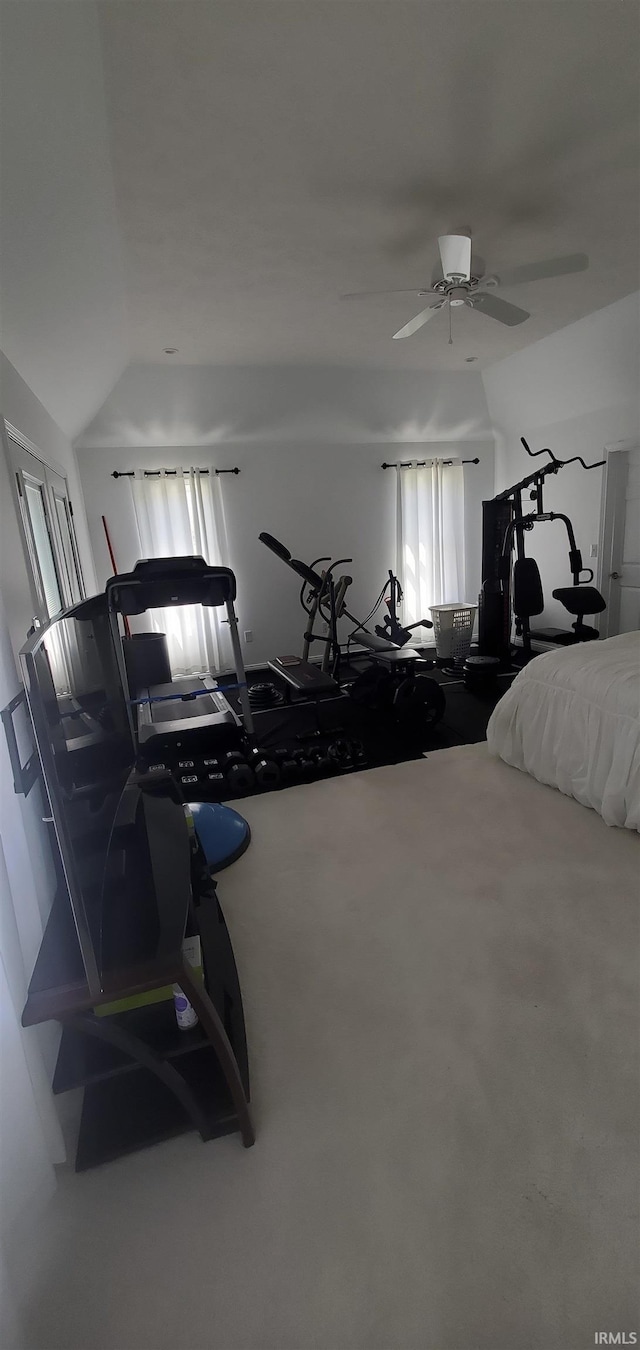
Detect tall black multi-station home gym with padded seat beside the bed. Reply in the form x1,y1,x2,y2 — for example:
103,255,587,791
477,436,605,674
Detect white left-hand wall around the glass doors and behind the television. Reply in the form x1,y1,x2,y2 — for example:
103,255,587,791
0,352,86,1301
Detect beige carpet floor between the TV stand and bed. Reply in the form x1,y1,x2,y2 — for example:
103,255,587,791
15,745,640,1350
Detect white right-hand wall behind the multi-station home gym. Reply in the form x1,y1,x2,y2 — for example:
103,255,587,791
482,294,640,628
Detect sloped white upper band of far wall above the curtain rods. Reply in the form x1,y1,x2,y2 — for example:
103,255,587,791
77,359,491,450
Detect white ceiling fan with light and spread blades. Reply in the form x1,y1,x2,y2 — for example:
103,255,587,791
340,235,589,342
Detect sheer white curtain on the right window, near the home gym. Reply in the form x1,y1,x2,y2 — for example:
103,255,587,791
396,459,466,624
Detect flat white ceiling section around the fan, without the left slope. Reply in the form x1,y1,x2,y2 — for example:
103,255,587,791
100,0,640,370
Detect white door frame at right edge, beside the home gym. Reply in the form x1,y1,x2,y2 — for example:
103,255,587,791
597,440,639,637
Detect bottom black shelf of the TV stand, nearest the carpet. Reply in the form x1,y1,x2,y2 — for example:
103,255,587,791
76,1045,238,1172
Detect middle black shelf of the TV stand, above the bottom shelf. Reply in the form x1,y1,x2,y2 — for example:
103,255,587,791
53,1000,208,1094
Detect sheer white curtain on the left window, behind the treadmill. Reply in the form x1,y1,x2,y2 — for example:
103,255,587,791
128,468,230,675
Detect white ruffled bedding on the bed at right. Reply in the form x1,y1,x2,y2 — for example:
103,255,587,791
486,633,640,830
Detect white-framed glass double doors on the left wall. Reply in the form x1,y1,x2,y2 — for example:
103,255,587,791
5,428,85,624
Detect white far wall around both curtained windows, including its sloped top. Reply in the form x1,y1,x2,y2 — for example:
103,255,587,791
77,366,493,664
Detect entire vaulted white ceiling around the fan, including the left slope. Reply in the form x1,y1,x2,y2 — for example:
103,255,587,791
0,0,640,433
